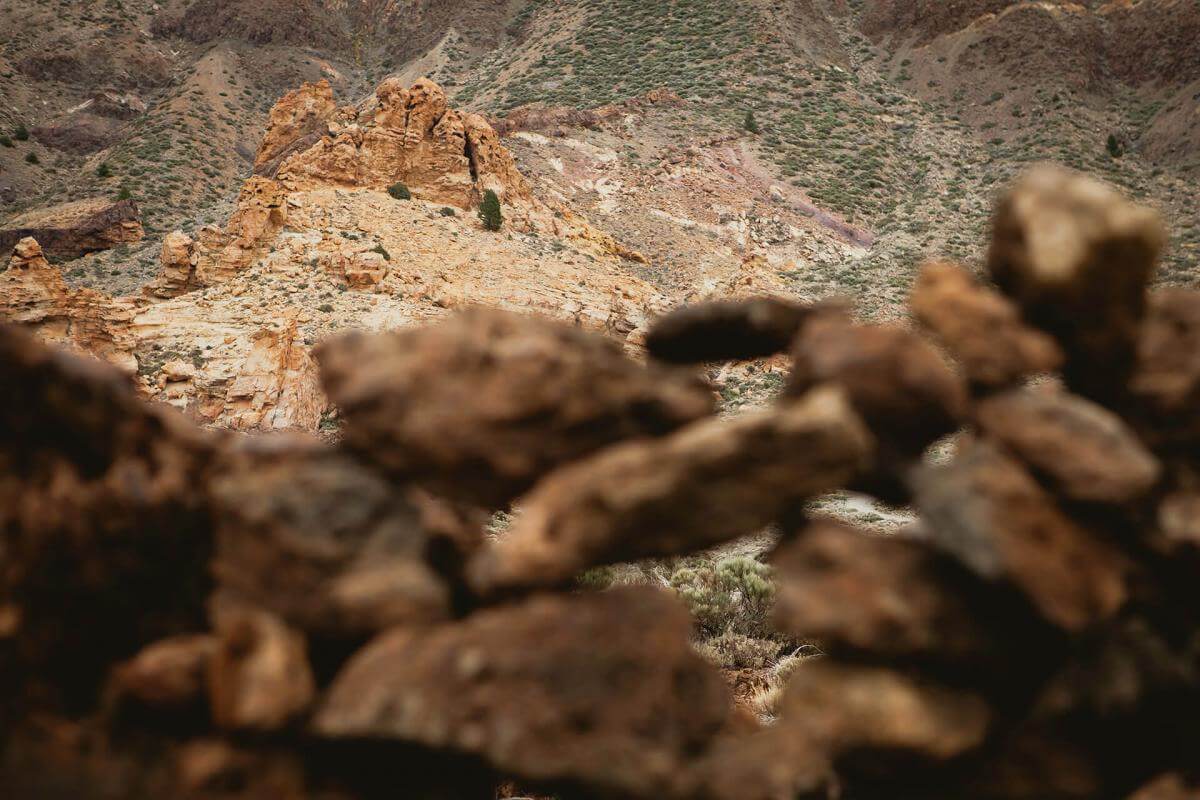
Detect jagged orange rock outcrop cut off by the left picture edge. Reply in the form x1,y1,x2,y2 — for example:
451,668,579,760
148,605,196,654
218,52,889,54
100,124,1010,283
0,239,138,374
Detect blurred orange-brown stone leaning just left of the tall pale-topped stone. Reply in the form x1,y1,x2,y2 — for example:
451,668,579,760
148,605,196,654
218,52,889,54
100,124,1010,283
911,261,1063,389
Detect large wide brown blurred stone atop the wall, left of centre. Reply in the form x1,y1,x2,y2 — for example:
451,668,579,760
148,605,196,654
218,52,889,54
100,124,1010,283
319,309,713,507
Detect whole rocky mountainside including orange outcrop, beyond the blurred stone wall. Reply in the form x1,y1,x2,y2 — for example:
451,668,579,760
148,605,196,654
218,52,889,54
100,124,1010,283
0,0,1200,417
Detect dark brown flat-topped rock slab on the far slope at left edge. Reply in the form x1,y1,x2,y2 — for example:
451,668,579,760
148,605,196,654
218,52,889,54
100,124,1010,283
0,198,143,259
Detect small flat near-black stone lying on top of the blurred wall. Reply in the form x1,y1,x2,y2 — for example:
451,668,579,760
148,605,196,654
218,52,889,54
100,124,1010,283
646,297,811,363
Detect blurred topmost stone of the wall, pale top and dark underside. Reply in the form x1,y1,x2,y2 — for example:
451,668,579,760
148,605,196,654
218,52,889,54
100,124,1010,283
988,167,1165,395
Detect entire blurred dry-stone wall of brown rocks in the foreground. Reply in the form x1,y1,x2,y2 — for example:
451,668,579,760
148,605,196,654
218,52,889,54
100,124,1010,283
0,164,1200,800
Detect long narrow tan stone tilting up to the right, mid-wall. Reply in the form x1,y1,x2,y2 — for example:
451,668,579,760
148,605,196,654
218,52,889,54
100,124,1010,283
469,390,872,591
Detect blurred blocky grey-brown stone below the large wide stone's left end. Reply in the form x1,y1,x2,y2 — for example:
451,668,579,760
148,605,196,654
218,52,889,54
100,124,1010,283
211,435,450,639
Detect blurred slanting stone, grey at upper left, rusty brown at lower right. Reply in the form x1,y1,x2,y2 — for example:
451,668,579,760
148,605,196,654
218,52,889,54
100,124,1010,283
916,441,1128,631
